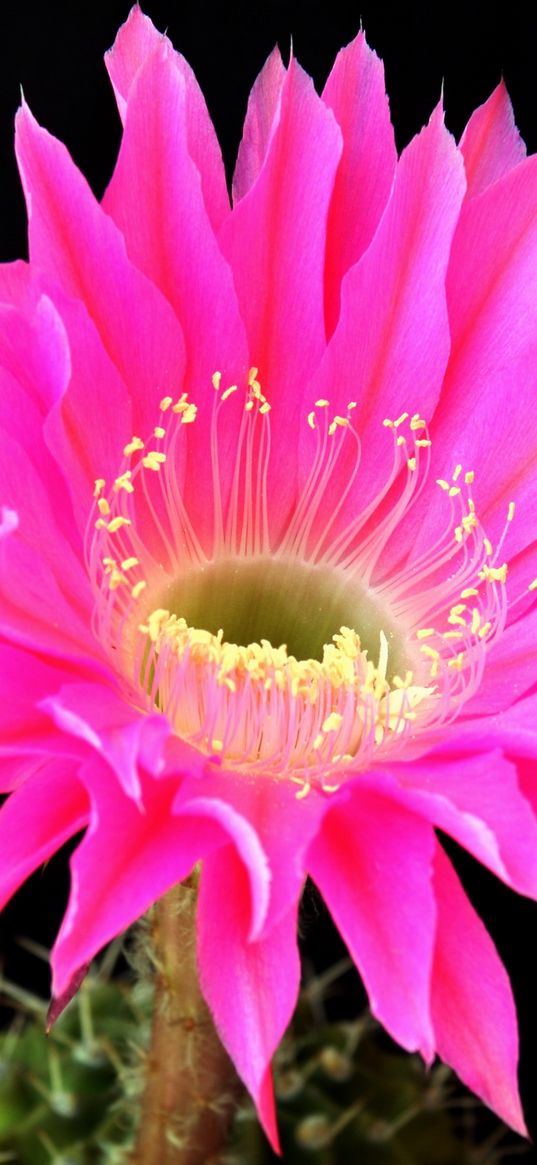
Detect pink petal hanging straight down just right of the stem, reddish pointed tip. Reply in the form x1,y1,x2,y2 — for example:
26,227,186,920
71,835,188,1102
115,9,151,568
198,847,301,1152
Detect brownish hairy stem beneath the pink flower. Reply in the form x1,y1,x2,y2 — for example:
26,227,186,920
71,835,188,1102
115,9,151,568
132,876,239,1165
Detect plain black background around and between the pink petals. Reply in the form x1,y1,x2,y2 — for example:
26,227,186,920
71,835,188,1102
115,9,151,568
0,0,537,1162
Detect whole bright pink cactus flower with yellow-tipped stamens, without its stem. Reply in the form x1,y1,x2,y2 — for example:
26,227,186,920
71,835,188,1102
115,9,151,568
0,8,537,1143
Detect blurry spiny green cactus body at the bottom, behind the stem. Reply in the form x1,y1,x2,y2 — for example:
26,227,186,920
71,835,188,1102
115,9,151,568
0,953,522,1165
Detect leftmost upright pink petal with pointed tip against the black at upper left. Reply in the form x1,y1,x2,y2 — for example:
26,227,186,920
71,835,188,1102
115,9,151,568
16,106,184,439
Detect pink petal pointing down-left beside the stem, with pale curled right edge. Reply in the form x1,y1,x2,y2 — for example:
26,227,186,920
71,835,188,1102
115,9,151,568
52,761,268,996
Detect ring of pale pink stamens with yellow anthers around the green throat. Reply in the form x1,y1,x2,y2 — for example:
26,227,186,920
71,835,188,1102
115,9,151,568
87,368,524,797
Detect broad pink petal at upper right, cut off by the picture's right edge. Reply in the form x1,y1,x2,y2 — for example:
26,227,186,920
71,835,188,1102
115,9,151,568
416,157,537,561
